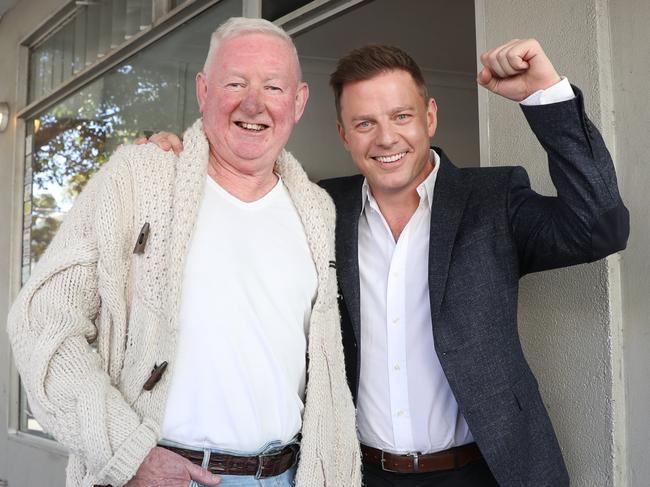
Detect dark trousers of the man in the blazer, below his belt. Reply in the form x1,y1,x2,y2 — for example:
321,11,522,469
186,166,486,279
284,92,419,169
363,460,499,487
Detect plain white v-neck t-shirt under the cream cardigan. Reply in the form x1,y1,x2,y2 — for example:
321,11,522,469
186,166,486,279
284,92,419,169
162,177,317,452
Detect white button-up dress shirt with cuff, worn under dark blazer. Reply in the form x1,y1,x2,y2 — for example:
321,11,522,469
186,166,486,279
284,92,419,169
357,78,574,453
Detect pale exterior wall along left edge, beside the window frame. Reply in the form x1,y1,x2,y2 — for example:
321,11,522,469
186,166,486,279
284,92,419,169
0,0,67,487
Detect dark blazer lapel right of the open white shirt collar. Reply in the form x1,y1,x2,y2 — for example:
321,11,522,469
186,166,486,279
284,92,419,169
429,148,470,328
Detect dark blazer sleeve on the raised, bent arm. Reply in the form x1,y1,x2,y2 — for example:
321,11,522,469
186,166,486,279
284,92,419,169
508,87,629,275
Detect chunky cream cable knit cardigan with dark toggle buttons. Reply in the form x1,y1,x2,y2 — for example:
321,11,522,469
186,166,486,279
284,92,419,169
8,120,361,487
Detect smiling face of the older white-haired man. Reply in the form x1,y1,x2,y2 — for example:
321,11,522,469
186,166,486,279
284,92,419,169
196,33,309,175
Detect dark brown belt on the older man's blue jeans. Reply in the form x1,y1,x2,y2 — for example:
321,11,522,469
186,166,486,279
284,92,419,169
159,445,299,479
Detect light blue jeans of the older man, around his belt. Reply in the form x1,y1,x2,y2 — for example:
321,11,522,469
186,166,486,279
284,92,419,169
160,440,297,487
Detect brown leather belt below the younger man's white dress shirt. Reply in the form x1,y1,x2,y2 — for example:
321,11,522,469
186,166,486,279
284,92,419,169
361,443,483,473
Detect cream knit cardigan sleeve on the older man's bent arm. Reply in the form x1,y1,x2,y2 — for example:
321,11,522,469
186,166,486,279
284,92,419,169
7,151,157,486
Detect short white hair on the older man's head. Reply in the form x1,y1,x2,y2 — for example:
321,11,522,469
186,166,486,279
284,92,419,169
203,17,302,80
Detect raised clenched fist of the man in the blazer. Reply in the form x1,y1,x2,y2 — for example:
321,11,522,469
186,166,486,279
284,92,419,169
477,39,561,101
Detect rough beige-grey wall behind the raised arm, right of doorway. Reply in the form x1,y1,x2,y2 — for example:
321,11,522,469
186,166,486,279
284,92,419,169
479,0,620,487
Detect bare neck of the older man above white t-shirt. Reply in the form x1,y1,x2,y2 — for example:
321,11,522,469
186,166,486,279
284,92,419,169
208,147,278,203
